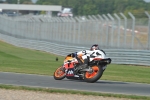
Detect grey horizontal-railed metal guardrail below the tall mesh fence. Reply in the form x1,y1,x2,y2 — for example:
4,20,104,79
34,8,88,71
0,33,150,66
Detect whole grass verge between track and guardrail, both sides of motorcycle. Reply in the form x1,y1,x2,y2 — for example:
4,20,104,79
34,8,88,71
0,41,150,84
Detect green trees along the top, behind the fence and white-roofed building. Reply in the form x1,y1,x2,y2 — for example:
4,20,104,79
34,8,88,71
1,0,150,18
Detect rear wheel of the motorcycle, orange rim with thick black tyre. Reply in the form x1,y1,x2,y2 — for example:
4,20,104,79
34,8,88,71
84,65,103,83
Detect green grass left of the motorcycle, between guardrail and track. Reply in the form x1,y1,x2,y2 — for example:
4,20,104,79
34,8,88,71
0,39,64,75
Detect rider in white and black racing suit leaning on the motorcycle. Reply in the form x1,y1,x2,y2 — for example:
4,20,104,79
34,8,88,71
74,44,106,68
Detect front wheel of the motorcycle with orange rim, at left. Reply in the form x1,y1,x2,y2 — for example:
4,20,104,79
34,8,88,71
54,66,66,80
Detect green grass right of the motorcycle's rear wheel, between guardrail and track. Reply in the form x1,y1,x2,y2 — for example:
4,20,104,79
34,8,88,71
101,64,150,84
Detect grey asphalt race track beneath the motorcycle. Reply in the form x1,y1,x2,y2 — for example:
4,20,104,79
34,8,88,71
0,72,150,96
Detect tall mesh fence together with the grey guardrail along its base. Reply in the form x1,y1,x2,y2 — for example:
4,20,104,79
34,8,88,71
0,12,150,66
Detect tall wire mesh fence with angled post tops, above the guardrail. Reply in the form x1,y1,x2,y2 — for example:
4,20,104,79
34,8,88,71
0,12,150,50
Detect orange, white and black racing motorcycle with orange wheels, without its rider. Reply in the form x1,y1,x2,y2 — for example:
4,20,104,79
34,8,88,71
53,52,111,83
